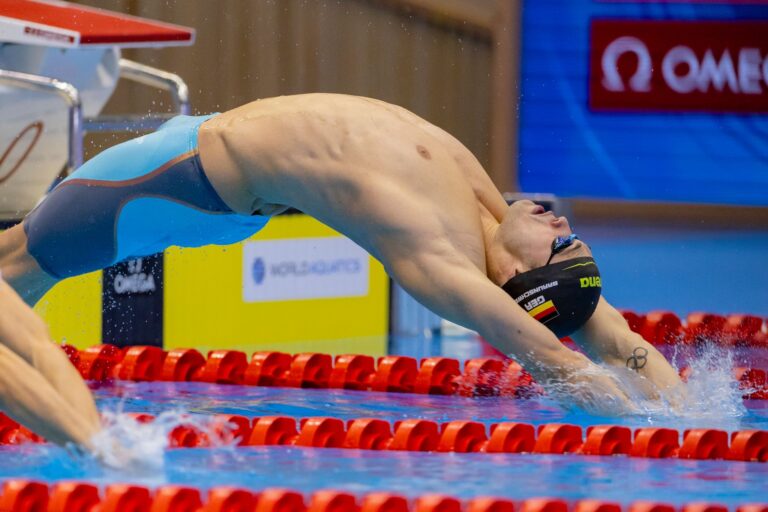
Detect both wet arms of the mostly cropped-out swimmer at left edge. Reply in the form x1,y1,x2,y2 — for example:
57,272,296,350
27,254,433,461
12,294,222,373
0,275,100,448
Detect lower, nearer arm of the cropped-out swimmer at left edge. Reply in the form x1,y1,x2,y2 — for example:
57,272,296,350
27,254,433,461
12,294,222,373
0,345,98,449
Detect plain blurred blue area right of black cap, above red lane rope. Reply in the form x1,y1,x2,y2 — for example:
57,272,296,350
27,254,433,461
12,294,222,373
572,223,768,317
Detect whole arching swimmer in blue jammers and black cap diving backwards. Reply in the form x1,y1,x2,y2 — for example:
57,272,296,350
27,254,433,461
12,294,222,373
0,94,680,413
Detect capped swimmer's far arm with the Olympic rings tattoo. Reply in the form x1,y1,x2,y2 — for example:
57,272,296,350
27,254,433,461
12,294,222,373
572,297,684,403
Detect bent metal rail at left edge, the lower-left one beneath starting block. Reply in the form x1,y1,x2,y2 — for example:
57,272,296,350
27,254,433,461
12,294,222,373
0,69,83,173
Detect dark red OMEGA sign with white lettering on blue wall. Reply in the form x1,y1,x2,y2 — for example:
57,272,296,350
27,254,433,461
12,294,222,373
589,20,768,112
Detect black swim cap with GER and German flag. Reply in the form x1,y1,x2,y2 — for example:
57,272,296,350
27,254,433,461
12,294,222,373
502,257,602,338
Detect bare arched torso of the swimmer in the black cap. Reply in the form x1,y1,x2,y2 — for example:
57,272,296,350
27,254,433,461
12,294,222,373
199,94,506,271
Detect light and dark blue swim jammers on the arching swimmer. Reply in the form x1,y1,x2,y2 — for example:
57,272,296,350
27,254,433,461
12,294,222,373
24,116,269,279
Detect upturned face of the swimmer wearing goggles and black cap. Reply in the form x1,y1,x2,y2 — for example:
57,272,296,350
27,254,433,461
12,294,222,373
497,200,592,272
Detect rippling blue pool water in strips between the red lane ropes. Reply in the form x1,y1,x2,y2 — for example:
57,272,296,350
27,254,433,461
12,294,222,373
0,372,768,505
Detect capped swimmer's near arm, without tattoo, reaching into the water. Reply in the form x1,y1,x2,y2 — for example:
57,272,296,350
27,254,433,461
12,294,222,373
385,242,634,414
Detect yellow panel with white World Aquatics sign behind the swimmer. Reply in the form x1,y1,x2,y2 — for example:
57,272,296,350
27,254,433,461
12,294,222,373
36,215,389,355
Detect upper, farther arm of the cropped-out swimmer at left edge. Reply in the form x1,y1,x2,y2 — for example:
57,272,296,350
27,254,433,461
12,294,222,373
0,278,100,429
